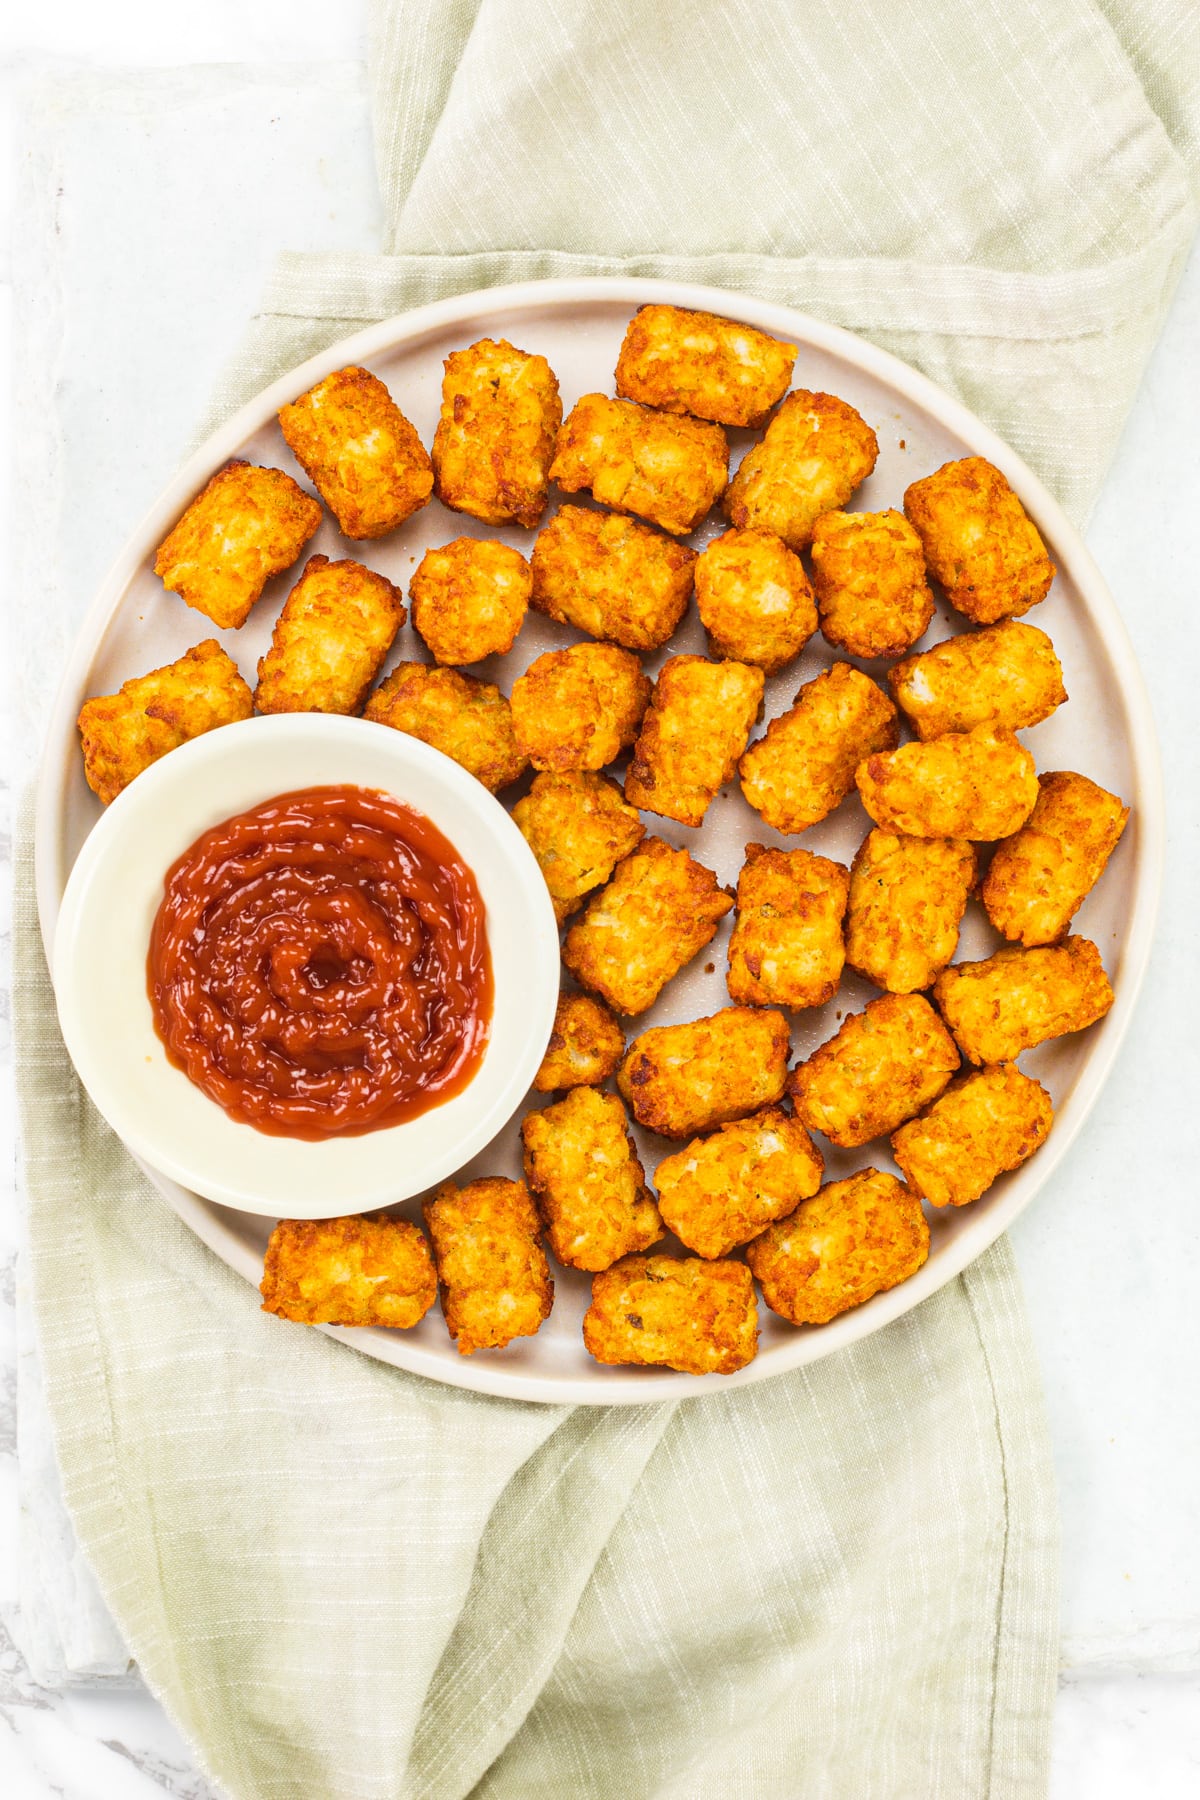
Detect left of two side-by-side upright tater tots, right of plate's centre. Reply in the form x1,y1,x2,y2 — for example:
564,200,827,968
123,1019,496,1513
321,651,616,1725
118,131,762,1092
727,844,849,1008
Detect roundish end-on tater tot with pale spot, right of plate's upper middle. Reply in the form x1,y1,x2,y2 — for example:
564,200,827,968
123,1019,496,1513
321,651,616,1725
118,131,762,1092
696,531,817,675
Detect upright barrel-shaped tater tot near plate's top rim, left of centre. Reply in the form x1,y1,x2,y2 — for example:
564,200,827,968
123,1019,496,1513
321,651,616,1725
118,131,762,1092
434,338,563,526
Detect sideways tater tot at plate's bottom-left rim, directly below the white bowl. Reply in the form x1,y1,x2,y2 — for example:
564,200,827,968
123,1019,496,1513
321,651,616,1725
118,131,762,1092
259,1213,437,1332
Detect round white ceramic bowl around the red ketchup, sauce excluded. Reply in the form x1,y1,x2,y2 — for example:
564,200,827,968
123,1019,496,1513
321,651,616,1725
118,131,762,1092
54,713,558,1219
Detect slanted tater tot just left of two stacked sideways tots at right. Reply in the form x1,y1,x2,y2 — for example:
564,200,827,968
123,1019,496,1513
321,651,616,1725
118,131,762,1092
738,662,900,832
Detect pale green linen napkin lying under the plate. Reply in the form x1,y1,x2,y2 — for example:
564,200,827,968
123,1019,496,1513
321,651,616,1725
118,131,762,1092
16,0,1200,1800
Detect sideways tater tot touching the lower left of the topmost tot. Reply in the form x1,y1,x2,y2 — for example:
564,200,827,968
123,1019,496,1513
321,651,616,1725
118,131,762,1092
551,394,729,536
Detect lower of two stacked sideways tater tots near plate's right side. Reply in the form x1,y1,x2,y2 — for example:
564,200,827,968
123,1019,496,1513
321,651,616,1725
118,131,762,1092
855,725,1038,842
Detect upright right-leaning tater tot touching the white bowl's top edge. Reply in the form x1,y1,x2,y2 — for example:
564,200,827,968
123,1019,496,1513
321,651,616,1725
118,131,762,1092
254,556,407,713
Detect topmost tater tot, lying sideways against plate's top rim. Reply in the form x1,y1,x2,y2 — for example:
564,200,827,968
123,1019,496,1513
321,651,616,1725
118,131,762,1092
617,304,795,427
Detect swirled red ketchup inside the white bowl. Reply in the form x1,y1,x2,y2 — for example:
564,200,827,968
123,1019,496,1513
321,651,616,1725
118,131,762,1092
148,787,491,1137
